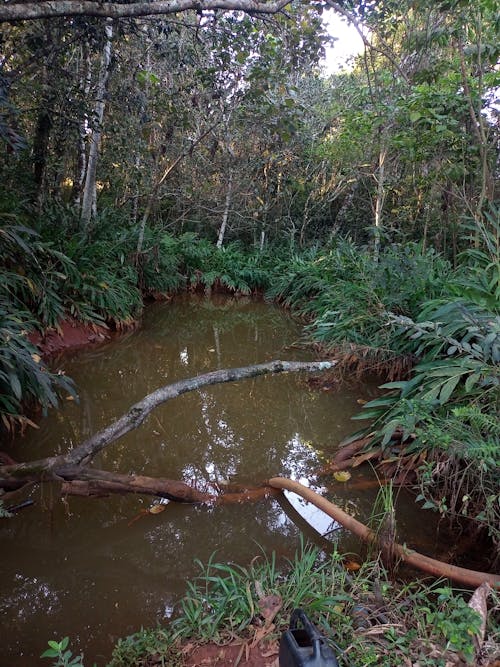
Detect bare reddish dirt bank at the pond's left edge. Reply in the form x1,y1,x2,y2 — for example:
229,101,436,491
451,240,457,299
28,319,113,358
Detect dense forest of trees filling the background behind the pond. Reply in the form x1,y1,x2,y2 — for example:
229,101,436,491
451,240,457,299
0,0,499,248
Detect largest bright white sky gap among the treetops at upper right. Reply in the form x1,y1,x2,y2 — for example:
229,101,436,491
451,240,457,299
323,11,363,76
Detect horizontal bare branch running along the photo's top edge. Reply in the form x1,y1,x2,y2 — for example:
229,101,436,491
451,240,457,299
0,0,290,22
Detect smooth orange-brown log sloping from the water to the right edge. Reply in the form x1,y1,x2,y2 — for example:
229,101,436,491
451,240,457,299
268,477,500,589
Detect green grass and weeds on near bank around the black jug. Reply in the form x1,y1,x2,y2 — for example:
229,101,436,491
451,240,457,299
110,546,499,667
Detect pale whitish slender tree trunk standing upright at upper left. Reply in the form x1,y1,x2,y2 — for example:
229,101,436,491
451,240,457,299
81,19,113,229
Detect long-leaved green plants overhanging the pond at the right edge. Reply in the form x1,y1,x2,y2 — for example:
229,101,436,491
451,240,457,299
357,278,500,546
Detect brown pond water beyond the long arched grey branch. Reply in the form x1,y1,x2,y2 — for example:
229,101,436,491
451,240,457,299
25,297,304,464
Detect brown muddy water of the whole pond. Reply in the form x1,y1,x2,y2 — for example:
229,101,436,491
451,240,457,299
0,297,442,667
